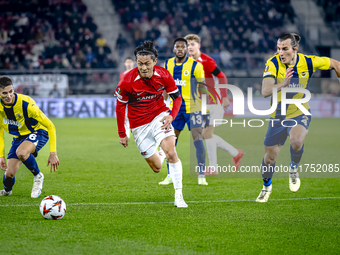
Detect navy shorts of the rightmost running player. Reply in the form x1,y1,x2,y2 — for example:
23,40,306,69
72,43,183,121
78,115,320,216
264,115,312,146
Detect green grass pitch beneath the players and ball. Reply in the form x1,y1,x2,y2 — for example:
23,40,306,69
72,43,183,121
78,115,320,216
0,119,340,254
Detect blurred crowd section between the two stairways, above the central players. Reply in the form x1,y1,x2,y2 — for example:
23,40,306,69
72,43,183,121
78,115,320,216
112,0,294,68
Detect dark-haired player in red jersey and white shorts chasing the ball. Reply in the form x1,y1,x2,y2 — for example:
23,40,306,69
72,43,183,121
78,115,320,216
115,41,188,207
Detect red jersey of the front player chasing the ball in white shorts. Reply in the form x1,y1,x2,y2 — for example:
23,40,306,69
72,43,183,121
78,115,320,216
115,66,178,137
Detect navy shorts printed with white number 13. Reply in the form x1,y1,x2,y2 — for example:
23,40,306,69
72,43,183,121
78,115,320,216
171,110,203,130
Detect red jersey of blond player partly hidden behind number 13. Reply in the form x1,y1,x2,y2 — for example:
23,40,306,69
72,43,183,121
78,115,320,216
196,53,228,104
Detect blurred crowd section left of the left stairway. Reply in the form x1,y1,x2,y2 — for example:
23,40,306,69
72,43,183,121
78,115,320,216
0,0,118,70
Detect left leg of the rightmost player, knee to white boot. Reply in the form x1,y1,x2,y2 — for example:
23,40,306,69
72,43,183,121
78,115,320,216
256,145,282,202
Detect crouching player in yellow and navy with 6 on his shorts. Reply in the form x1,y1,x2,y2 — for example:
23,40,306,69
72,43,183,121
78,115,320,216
0,77,59,198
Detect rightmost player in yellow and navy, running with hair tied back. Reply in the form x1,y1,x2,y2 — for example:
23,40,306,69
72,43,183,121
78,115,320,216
256,33,340,202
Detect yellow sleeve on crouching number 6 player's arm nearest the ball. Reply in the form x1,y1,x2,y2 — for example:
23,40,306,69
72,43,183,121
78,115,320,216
27,100,57,152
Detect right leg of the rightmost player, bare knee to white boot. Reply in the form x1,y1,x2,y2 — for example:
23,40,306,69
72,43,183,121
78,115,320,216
289,125,308,192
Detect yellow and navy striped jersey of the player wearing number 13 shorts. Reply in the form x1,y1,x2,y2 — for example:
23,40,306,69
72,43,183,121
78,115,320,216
164,57,204,113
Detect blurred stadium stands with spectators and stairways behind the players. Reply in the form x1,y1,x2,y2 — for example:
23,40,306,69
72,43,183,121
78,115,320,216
0,0,340,98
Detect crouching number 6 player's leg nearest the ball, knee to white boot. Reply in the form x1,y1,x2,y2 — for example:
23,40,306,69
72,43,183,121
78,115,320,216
16,141,44,198
